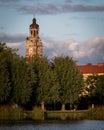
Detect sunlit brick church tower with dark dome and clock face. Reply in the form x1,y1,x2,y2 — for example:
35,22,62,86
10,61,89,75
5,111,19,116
26,18,42,63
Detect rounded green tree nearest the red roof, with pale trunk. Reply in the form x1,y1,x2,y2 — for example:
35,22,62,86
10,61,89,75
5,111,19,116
53,56,83,110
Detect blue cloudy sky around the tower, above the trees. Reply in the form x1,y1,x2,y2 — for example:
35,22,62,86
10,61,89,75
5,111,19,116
0,0,104,65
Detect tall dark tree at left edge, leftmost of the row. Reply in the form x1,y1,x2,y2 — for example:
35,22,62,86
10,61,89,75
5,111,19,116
0,43,14,103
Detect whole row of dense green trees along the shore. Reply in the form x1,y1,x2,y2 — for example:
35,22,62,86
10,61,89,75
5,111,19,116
0,43,104,110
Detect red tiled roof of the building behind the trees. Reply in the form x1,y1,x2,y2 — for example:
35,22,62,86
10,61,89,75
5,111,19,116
77,63,104,74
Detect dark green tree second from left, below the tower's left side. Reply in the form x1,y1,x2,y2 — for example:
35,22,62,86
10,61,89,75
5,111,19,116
11,57,34,104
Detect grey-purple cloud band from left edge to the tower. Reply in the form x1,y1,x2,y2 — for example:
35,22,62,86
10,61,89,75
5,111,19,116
0,33,26,42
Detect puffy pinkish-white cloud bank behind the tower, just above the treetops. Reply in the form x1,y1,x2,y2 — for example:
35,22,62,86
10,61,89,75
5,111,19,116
7,37,104,64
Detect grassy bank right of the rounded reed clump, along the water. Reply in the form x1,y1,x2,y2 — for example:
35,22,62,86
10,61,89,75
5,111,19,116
46,107,104,120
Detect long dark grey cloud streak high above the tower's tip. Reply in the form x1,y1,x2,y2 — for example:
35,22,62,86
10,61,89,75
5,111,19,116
18,3,104,15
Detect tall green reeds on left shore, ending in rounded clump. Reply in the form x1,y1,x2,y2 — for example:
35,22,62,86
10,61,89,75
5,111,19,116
0,107,44,120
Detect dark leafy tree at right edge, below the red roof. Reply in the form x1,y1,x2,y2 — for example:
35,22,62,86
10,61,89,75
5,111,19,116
86,75,104,104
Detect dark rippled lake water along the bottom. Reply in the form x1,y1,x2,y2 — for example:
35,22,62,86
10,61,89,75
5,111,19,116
0,120,104,130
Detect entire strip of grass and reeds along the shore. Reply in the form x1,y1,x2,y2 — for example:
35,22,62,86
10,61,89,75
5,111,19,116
0,106,104,121
